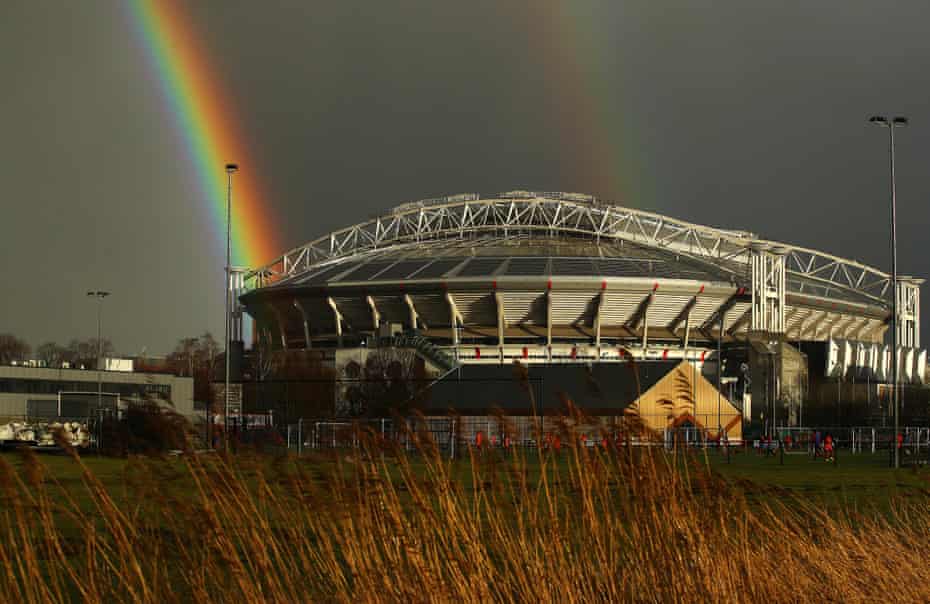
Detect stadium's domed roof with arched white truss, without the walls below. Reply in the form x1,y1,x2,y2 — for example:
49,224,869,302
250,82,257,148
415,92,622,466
246,191,891,308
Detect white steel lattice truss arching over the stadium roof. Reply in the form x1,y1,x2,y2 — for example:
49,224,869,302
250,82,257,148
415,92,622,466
246,191,891,306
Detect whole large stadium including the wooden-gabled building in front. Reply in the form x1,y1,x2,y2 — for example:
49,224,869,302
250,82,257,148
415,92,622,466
232,191,926,439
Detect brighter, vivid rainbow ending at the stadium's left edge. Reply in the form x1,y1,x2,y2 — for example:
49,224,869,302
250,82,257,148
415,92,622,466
128,0,283,267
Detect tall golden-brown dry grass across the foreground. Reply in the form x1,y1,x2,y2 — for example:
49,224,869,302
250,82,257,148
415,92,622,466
0,424,930,603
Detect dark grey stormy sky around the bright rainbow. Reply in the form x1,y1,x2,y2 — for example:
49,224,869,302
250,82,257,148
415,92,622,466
0,0,930,354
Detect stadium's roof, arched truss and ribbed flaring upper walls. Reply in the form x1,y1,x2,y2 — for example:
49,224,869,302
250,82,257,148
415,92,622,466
240,191,919,355
